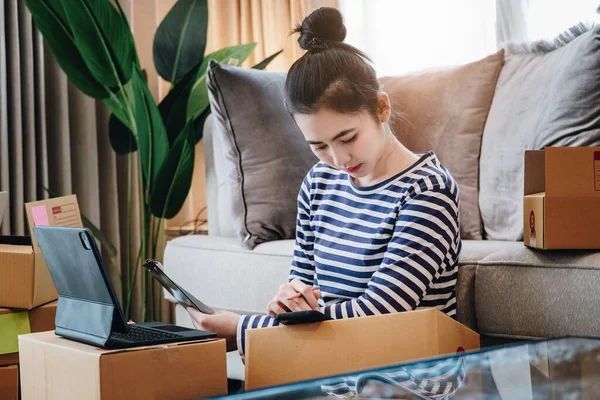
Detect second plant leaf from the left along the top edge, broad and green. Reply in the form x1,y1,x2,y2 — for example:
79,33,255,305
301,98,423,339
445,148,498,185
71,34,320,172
61,0,135,88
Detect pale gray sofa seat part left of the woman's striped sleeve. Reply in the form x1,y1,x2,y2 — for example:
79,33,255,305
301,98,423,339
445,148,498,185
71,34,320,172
164,235,294,314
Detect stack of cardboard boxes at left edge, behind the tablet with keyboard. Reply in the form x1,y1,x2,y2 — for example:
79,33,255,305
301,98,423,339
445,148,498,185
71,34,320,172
0,196,82,399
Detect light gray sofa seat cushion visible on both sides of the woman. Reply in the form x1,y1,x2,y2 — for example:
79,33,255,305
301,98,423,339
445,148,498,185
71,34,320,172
164,235,523,329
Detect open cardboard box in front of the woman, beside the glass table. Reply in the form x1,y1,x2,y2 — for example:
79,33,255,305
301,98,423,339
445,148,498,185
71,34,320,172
245,309,479,390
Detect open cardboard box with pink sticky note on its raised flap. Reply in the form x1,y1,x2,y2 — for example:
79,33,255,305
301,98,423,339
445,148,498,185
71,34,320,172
0,196,83,310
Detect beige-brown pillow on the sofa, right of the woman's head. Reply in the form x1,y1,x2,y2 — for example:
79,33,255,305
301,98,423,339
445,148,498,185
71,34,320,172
381,50,504,239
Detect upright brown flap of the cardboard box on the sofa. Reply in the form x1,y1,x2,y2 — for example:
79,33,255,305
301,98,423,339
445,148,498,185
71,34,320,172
545,147,600,197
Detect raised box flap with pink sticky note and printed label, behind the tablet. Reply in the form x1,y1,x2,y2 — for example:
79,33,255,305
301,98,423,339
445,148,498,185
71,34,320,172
25,195,83,252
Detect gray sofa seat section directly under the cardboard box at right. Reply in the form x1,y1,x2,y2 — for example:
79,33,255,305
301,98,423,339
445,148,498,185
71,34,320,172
475,247,600,338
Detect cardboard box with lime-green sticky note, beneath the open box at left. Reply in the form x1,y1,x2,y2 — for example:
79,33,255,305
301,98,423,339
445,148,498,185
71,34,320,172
0,301,58,366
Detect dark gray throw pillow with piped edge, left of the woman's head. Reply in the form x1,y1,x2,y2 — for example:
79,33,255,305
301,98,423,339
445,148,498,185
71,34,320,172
207,61,318,249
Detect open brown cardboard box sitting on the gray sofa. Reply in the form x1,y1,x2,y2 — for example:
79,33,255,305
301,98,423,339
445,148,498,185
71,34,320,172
523,147,600,249
